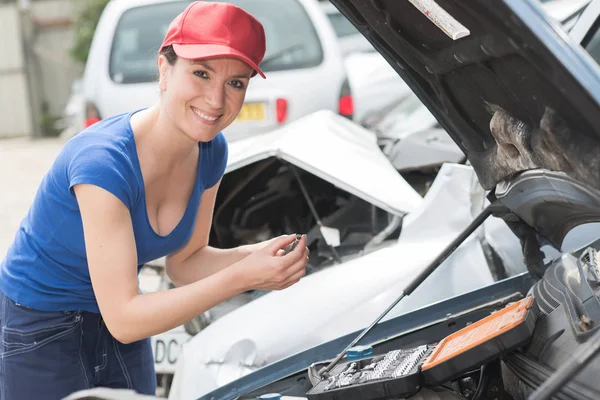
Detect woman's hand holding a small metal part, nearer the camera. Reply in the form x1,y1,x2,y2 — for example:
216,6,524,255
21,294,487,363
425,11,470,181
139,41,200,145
232,235,309,290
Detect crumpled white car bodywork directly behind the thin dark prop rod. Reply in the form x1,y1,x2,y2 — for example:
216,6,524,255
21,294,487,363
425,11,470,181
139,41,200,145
169,158,525,400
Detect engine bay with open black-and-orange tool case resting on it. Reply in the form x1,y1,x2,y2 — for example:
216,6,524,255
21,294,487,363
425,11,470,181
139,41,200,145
240,241,600,400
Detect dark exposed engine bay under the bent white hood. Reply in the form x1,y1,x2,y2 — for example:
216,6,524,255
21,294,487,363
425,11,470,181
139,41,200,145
210,157,400,273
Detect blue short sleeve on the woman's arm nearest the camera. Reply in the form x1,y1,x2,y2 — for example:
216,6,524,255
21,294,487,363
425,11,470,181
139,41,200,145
68,145,134,209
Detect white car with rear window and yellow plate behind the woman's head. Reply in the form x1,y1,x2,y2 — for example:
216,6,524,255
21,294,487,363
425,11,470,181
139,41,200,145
83,0,353,141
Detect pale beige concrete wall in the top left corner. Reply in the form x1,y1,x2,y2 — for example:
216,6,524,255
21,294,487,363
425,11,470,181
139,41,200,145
0,0,86,138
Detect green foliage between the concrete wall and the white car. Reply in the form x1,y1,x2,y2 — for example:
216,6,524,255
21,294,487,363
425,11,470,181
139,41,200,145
71,0,109,64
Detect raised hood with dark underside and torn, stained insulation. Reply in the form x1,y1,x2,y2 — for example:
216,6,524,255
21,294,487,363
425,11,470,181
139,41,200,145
331,0,600,244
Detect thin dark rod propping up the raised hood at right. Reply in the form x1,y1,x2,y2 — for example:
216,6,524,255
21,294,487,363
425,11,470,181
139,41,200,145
318,203,505,378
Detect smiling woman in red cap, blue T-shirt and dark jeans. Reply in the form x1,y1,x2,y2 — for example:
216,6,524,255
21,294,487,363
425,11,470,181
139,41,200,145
0,1,308,400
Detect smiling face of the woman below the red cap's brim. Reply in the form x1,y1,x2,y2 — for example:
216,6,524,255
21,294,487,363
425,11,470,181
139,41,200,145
158,56,253,142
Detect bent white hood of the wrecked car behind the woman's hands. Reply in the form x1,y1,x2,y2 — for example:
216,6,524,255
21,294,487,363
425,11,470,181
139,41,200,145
225,110,422,215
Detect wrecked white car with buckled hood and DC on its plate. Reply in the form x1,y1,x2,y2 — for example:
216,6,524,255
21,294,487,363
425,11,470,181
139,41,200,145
140,110,423,393
